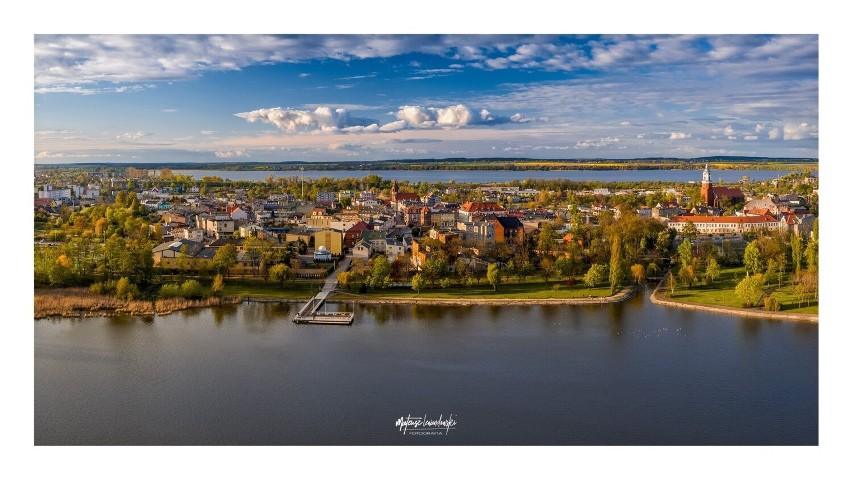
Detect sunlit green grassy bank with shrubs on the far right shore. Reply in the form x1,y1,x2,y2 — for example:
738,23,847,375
663,267,819,314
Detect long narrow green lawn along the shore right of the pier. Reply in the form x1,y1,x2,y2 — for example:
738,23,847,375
344,282,610,299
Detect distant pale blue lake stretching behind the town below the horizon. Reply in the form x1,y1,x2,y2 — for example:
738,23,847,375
173,170,817,183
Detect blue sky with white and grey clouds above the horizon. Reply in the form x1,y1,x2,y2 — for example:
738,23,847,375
33,35,819,163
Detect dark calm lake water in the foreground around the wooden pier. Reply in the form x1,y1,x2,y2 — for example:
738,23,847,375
34,295,819,445
